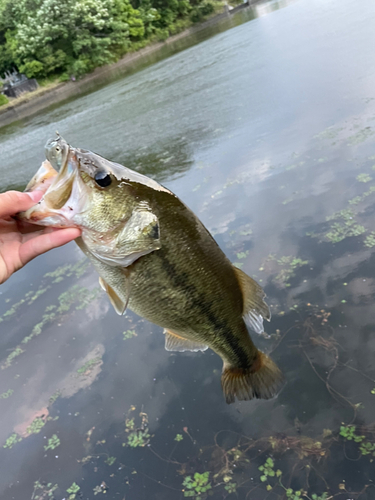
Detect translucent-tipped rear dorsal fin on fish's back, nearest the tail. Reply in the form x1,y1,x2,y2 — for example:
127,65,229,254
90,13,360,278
233,266,271,333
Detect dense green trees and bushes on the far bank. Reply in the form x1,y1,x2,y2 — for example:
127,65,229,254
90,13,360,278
0,0,214,79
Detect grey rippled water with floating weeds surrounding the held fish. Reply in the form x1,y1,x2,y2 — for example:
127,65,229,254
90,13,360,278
0,0,375,500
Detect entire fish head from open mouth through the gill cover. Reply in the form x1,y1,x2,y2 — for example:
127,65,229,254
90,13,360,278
18,135,164,266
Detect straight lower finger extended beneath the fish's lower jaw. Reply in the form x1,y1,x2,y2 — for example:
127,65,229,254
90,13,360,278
20,228,81,265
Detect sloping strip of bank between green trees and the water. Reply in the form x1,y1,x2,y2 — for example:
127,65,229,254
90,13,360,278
0,0,261,129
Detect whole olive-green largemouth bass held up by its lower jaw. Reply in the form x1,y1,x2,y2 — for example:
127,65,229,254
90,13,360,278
18,135,283,404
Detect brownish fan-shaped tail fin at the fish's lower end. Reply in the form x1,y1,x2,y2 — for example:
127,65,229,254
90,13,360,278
221,351,284,404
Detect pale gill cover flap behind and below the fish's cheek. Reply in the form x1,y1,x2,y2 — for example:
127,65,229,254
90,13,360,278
82,205,161,267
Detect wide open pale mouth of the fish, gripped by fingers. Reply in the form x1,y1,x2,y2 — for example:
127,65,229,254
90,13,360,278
18,135,83,227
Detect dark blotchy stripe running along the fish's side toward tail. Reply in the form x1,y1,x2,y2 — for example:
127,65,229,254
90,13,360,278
155,252,249,368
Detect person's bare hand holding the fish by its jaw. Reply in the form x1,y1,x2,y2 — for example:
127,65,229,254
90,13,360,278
0,191,81,284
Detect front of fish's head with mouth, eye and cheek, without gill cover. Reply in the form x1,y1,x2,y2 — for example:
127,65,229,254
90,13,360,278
19,135,134,232
